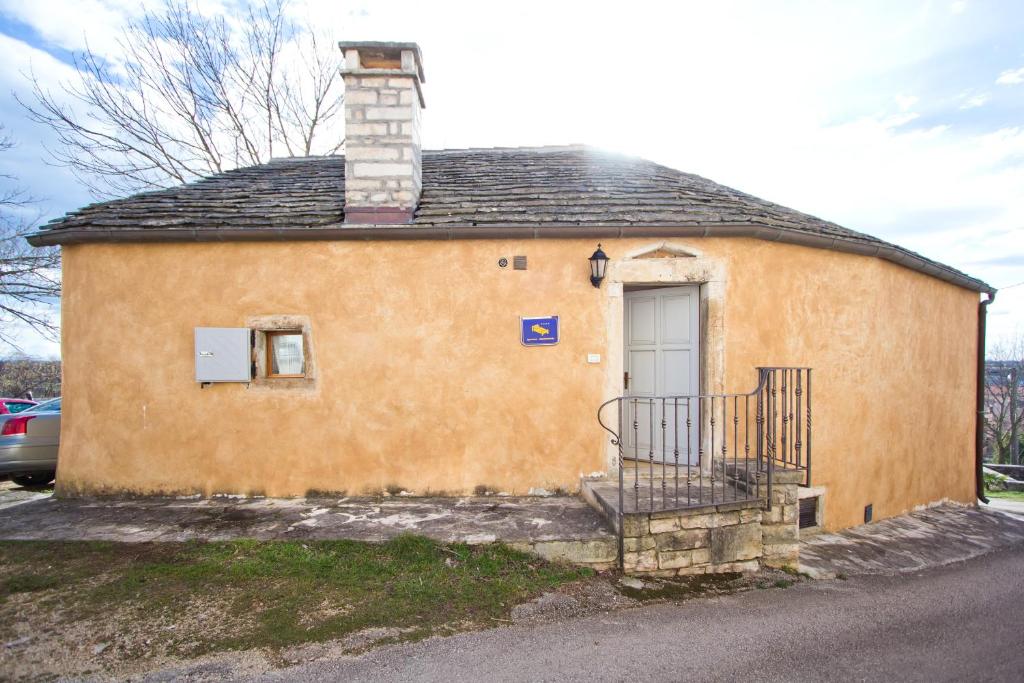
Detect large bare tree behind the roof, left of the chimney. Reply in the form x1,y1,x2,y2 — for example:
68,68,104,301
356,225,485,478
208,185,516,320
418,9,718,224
18,0,344,197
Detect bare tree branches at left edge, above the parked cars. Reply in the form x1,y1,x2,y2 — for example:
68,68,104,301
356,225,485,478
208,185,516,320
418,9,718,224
0,124,60,349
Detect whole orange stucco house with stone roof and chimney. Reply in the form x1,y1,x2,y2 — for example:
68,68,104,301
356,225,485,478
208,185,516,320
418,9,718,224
31,44,992,528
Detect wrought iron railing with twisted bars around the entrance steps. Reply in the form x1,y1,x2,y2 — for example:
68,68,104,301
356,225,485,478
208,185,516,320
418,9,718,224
598,368,811,518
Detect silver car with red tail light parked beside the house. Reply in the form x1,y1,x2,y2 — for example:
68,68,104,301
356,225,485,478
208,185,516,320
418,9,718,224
0,398,60,486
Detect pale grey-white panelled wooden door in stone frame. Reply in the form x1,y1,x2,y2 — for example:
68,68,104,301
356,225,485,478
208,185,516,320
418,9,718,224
624,285,700,465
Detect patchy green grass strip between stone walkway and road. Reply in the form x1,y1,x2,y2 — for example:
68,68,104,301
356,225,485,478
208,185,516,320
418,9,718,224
0,536,593,655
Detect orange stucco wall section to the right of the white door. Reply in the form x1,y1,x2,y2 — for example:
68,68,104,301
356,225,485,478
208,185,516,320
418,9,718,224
726,242,978,528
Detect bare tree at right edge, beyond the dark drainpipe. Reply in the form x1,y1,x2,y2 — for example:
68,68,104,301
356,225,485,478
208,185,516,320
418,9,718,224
985,335,1024,465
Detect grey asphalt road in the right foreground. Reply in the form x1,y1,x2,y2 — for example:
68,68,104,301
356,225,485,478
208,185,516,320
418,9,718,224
262,546,1024,683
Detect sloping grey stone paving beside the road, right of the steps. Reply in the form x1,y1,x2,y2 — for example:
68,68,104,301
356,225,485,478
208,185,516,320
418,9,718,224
800,506,1024,578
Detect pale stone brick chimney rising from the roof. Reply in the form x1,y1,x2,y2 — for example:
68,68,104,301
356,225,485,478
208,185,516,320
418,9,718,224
338,42,425,224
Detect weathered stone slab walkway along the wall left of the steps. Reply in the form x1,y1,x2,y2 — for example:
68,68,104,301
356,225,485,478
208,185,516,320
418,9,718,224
0,497,616,568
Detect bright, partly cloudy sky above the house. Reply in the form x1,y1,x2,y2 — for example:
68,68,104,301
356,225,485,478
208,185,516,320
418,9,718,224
0,0,1024,357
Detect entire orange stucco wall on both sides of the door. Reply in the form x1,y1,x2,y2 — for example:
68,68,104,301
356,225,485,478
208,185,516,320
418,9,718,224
58,239,977,528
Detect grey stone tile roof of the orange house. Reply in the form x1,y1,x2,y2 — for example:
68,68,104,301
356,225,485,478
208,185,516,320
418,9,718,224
31,146,991,291
